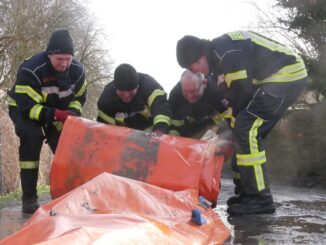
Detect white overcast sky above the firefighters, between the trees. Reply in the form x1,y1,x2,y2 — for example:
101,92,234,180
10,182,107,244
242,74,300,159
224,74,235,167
91,0,272,92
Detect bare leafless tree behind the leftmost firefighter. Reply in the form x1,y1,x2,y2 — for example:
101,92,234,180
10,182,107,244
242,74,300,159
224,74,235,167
0,0,111,118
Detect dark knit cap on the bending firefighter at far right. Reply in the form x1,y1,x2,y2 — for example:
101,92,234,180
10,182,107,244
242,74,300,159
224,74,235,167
177,36,204,68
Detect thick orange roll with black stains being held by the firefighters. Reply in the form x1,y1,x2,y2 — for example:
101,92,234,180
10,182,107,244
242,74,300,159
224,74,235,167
50,117,223,203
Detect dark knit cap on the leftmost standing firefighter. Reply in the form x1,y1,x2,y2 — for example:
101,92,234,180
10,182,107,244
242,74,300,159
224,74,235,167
46,29,74,55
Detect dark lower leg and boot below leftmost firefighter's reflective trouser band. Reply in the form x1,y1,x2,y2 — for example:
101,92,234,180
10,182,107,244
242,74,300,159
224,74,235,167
20,169,40,214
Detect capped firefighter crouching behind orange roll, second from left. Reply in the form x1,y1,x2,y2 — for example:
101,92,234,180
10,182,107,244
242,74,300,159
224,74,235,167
97,64,171,134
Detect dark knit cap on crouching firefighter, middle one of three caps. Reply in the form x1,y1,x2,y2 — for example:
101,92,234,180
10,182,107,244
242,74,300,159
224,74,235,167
114,64,139,91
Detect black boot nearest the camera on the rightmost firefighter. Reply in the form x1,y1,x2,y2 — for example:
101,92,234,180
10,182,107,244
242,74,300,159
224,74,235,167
227,192,275,215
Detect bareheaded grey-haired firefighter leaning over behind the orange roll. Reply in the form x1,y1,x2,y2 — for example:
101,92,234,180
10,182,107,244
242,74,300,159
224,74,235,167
169,70,227,137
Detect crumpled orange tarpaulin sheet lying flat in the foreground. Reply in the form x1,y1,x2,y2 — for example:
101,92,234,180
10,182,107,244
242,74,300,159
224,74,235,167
0,173,230,245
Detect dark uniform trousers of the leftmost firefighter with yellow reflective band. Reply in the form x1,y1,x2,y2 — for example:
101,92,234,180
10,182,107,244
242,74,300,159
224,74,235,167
9,107,60,200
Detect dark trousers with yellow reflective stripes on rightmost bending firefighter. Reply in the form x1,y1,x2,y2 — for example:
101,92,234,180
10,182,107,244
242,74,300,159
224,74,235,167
232,78,307,195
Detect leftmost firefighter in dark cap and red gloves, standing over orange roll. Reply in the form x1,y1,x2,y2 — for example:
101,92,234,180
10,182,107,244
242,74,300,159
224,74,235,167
8,29,86,213
